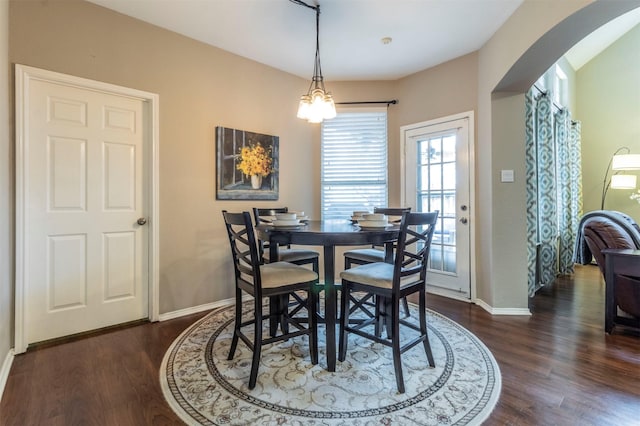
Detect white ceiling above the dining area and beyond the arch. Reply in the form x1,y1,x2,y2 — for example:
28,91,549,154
89,0,638,81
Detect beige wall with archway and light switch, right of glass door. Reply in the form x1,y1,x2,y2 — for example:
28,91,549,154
476,0,640,313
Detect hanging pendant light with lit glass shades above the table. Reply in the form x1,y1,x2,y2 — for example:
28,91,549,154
290,0,336,123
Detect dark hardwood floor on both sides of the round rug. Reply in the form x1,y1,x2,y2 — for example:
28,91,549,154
0,266,640,426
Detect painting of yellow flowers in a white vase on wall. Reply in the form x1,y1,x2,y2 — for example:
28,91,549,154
216,126,280,200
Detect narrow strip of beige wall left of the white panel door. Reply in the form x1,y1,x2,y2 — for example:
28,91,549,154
0,0,14,372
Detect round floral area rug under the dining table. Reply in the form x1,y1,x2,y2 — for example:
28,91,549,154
160,302,501,426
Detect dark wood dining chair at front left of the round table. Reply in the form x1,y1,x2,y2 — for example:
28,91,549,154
222,210,318,389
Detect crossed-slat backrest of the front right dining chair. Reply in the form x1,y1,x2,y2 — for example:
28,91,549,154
393,210,439,290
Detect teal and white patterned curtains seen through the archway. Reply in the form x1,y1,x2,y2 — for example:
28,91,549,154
525,87,582,297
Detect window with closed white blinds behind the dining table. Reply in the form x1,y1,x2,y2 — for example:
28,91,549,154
321,109,387,220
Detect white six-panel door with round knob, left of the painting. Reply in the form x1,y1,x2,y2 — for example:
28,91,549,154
24,79,149,344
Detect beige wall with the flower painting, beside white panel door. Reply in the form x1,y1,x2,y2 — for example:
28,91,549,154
10,1,319,313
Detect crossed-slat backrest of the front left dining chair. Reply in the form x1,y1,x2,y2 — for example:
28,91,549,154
222,210,262,297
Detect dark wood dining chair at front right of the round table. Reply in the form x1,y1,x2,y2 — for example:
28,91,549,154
338,211,438,393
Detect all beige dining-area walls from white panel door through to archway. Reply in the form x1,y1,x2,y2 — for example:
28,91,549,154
0,0,636,360
